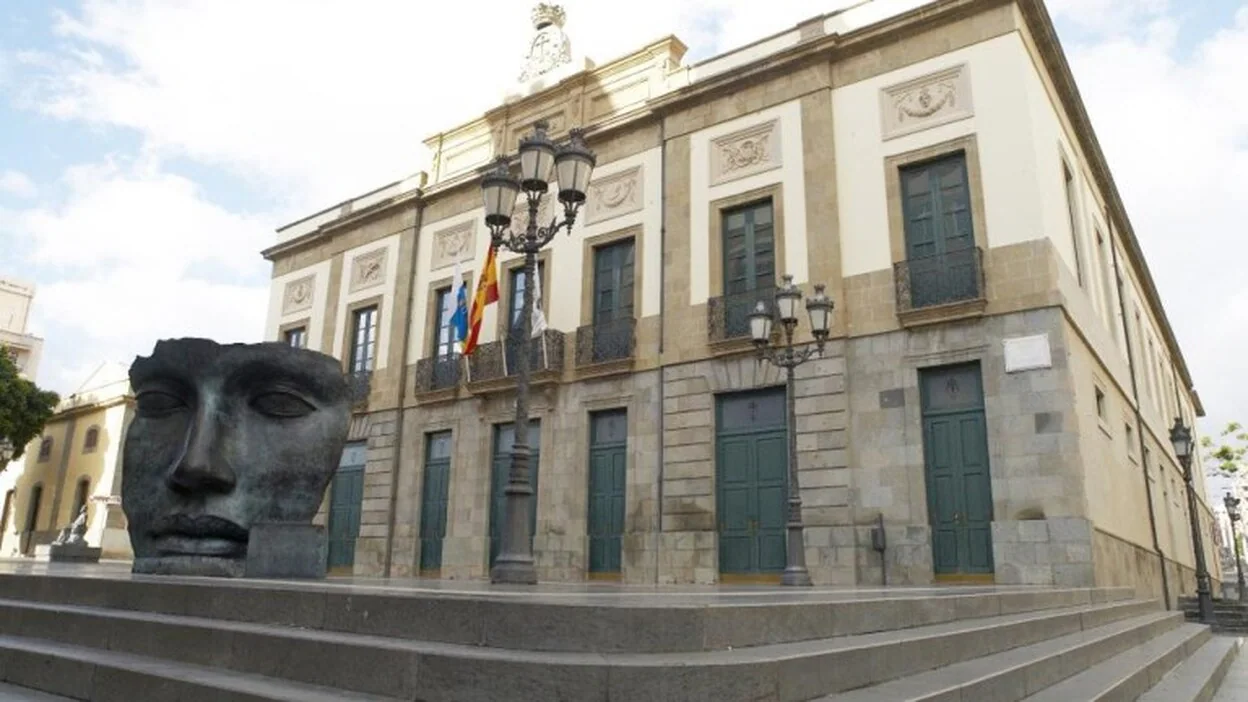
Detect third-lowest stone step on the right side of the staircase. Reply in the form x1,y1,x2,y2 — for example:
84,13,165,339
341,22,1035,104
824,604,1183,702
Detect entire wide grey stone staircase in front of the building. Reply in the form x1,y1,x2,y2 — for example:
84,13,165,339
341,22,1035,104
0,573,1239,702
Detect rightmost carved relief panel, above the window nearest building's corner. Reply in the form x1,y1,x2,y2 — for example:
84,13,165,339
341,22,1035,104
880,64,975,139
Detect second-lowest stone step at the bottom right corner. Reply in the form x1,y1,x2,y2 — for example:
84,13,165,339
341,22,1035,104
1025,623,1211,702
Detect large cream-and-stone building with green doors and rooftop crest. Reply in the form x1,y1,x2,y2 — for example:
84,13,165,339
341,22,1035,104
263,0,1221,597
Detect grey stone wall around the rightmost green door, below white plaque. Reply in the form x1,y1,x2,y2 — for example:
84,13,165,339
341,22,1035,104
847,307,1092,585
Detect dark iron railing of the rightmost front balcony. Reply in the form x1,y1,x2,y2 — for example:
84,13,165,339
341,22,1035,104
892,247,983,312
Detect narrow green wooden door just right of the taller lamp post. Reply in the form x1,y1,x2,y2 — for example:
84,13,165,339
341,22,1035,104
589,410,628,573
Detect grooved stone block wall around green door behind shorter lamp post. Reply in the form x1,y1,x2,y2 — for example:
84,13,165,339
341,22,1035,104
659,341,855,585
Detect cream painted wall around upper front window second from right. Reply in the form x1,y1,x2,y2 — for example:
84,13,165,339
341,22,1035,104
689,100,810,305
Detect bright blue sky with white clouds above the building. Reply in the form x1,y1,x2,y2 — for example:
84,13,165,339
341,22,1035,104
0,0,1248,444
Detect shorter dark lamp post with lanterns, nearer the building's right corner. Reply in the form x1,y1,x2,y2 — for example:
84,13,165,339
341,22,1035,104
750,275,832,587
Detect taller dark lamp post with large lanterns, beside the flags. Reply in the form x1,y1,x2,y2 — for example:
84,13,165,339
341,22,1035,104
480,121,597,585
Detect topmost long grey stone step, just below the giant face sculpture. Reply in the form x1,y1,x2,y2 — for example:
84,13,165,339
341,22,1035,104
0,573,1134,653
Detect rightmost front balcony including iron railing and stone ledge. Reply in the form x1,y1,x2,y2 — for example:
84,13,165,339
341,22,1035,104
892,249,987,326
